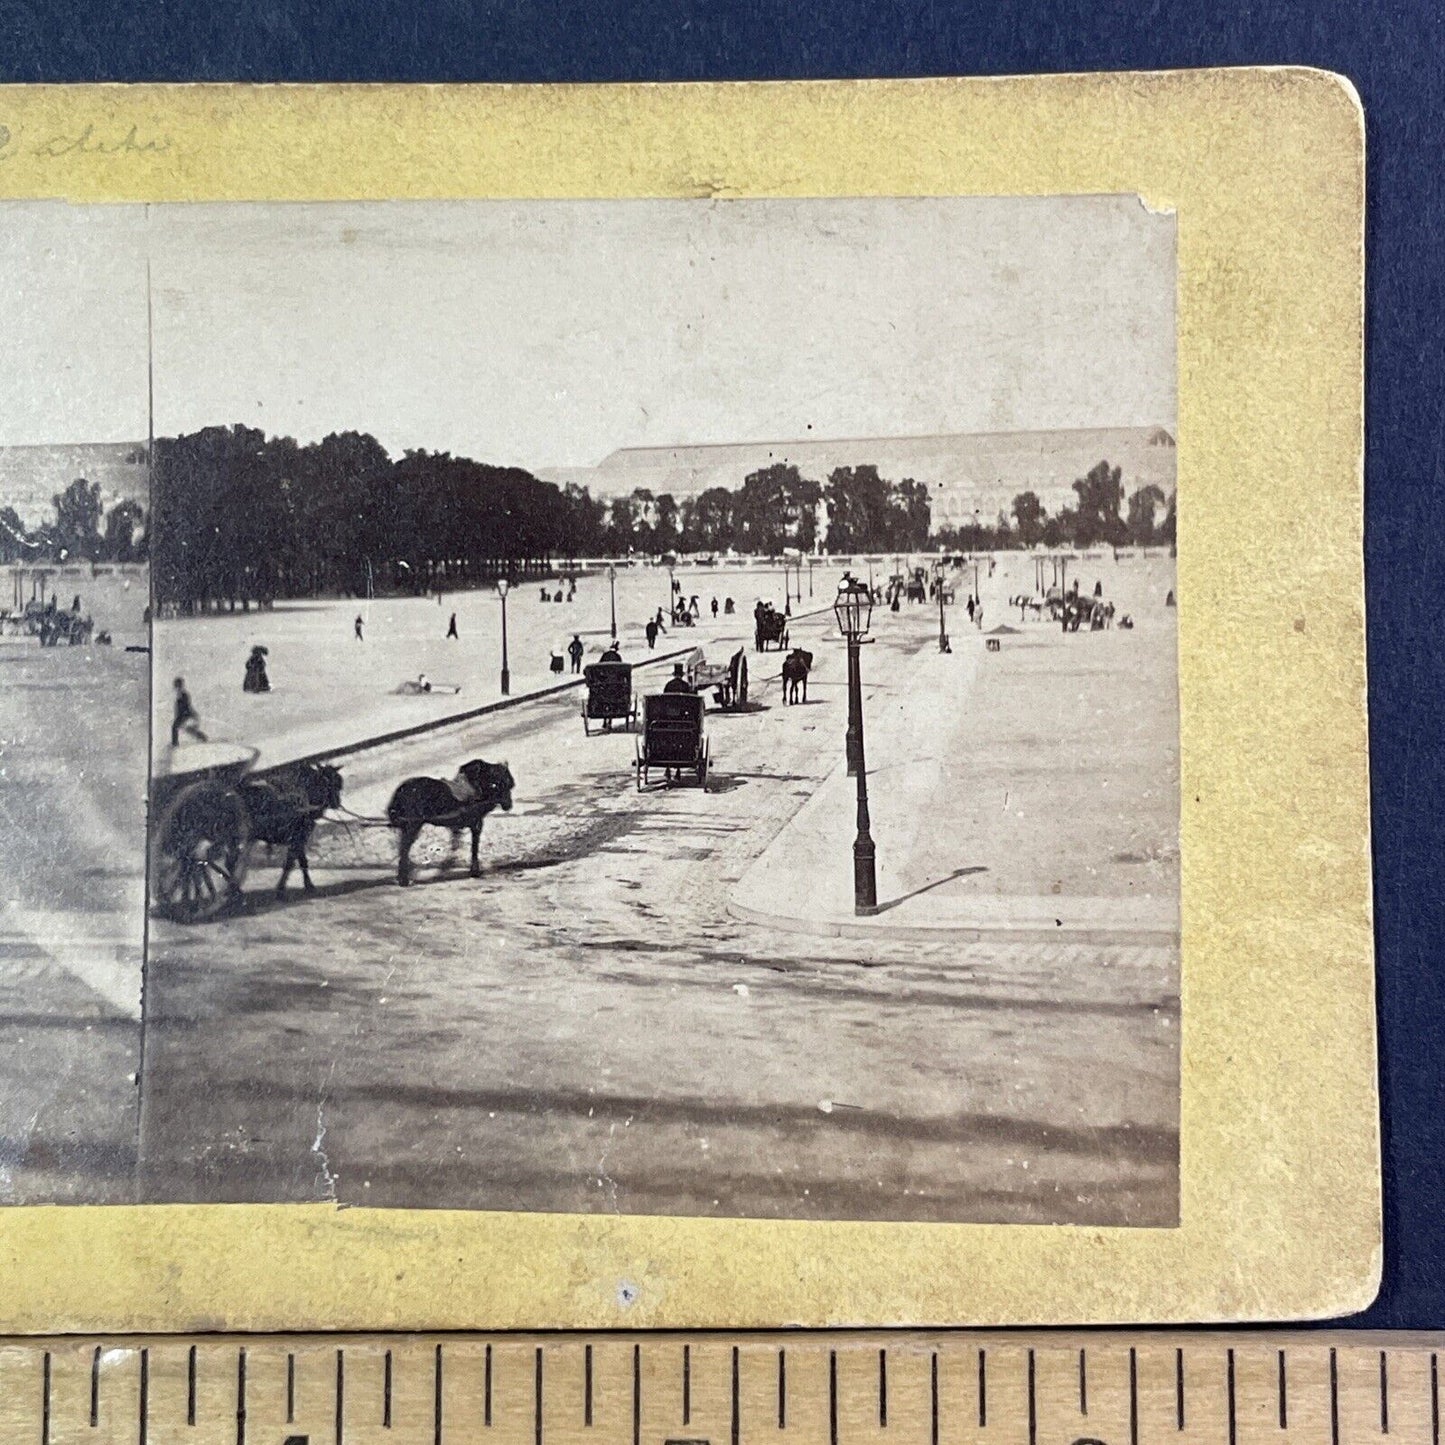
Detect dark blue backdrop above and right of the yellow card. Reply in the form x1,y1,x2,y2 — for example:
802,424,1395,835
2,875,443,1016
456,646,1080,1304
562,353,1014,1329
8,0,1445,1327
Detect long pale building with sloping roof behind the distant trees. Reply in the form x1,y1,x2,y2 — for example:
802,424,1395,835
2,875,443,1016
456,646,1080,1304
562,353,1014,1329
538,426,1176,530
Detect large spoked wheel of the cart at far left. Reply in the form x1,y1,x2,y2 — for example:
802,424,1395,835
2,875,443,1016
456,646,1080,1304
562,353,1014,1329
150,783,250,923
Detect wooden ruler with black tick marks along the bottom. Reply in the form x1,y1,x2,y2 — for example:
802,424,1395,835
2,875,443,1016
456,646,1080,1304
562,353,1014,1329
0,1331,1445,1445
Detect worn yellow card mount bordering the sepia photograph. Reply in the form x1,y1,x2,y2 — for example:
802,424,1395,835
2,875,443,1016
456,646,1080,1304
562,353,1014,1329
0,69,1380,1331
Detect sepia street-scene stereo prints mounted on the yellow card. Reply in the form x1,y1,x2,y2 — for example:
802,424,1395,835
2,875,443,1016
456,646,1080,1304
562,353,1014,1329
0,195,1182,1228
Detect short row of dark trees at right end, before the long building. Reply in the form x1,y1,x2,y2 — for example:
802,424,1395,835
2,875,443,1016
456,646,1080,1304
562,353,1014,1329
935,461,1175,552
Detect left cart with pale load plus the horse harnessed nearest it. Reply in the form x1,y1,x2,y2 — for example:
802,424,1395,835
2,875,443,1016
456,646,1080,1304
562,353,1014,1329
150,743,341,923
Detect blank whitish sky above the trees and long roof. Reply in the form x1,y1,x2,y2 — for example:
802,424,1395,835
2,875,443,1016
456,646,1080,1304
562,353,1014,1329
0,197,1175,468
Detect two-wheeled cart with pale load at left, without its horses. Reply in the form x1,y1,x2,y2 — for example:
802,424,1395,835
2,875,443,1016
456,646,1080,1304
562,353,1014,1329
150,743,257,923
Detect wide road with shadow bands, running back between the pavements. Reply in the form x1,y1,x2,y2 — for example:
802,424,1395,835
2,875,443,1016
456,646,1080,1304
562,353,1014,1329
140,611,1179,1224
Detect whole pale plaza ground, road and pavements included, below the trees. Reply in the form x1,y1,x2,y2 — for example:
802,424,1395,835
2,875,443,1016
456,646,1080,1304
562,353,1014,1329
137,551,1179,1225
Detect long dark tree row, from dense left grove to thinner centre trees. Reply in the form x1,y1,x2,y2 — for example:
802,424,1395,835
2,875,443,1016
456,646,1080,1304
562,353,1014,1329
152,426,929,611
